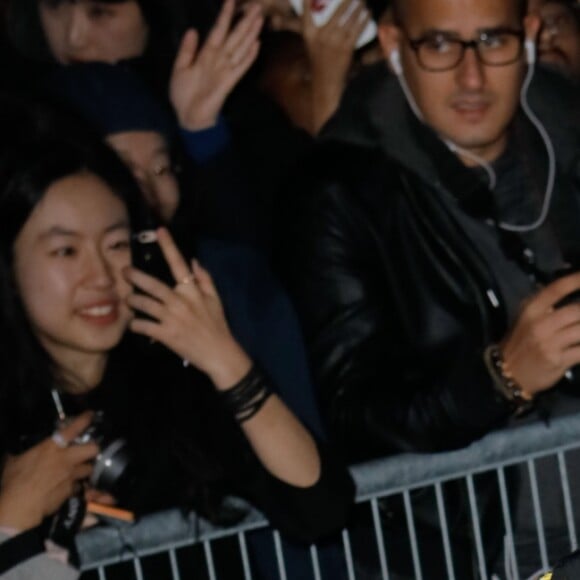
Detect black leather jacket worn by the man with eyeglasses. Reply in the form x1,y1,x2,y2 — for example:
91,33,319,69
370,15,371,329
290,63,580,460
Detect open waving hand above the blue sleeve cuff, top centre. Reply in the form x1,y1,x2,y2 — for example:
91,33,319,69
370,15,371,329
169,0,264,131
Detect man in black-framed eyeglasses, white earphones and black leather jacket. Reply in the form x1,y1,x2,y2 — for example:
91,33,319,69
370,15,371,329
289,0,580,579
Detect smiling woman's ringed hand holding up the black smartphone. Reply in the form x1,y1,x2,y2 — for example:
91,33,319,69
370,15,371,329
127,228,251,389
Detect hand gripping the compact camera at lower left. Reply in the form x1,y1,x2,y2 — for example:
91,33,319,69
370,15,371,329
0,413,99,530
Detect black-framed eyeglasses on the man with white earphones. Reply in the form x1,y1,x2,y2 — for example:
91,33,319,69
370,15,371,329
408,28,525,72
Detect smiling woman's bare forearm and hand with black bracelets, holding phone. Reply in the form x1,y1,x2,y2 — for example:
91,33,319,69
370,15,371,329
128,229,321,487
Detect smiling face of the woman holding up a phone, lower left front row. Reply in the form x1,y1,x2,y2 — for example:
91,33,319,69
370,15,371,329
14,172,131,368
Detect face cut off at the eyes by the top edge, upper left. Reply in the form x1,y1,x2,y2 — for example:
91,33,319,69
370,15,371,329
39,0,148,65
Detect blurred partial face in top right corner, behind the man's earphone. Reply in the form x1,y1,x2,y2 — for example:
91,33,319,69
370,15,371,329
529,0,580,79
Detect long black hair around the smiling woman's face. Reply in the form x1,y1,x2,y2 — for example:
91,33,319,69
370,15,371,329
0,115,145,447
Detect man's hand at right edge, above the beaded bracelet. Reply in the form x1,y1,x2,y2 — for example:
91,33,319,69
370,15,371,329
500,273,580,395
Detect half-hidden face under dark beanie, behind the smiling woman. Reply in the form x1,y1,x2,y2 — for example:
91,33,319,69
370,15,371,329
107,131,179,223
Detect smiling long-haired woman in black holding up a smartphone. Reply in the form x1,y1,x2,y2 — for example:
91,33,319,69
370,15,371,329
0,129,353,576
